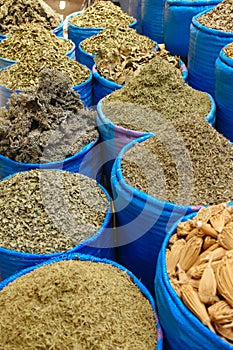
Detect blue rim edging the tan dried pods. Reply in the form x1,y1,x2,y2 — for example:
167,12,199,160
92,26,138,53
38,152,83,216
158,209,232,350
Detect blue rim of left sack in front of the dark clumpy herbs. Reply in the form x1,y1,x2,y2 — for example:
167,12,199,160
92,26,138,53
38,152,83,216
0,176,112,258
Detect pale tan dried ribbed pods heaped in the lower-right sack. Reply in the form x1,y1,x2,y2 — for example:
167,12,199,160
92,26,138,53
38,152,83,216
166,203,233,345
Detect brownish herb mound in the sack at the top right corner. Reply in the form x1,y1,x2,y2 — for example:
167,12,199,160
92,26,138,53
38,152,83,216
197,0,233,32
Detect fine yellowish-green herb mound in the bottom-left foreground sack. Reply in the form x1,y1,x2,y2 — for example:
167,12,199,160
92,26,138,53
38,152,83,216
0,260,156,350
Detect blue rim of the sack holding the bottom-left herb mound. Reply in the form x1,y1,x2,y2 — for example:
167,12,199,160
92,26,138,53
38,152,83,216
0,253,163,350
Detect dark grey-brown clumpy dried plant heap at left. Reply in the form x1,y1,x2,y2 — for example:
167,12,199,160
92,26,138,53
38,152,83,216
0,69,99,163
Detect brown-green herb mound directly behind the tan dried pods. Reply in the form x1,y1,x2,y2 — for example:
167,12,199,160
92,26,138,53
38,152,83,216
122,115,233,205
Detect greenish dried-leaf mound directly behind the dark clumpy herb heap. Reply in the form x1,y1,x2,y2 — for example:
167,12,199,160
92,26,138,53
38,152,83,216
0,52,90,90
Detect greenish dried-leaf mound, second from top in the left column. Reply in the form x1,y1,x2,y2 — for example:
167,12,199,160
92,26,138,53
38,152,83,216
0,23,73,61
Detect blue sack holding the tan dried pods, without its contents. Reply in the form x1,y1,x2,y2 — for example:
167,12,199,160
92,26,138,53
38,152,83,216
154,211,232,350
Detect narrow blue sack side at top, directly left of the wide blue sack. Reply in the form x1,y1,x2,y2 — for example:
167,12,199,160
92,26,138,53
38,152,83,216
141,0,166,44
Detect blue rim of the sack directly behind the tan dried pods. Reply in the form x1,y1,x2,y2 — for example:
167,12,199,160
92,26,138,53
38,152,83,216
111,133,203,214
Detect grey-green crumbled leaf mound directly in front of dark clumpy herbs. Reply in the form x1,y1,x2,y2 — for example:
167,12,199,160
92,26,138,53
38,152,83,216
0,169,109,254
